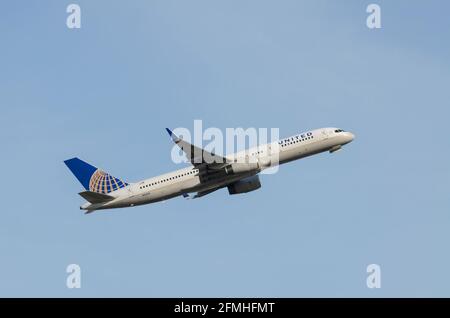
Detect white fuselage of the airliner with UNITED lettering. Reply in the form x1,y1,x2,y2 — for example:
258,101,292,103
80,128,354,211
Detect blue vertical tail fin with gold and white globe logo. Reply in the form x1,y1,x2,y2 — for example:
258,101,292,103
64,158,128,193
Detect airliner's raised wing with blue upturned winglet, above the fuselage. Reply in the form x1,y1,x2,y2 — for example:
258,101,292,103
166,128,230,168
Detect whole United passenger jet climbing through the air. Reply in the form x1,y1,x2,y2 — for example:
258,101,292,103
64,128,355,213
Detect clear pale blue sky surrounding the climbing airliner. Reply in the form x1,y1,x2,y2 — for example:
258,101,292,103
0,0,450,297
